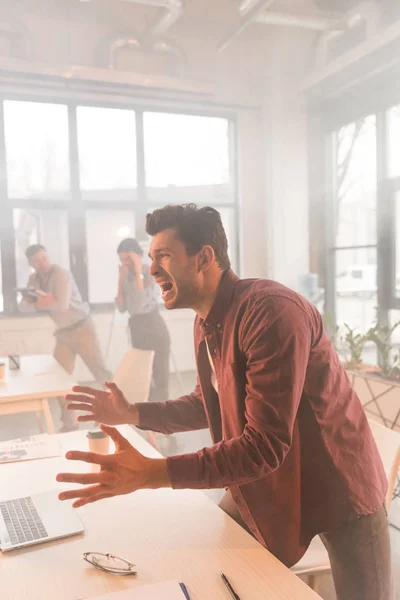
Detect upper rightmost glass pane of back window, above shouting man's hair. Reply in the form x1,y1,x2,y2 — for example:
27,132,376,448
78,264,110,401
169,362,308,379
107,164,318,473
144,113,230,191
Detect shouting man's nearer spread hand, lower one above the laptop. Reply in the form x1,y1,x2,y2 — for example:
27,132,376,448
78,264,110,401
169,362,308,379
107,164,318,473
56,425,171,508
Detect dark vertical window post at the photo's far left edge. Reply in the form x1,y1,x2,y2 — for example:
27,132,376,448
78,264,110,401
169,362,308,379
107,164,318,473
0,99,17,314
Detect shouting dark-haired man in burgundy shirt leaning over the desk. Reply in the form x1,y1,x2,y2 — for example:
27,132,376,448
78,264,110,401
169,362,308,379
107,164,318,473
58,205,393,600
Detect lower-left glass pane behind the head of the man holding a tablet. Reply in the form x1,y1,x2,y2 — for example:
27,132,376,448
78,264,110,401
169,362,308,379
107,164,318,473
14,209,70,287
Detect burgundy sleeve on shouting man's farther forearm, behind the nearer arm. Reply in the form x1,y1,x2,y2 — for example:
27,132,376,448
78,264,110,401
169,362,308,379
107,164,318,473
136,380,208,434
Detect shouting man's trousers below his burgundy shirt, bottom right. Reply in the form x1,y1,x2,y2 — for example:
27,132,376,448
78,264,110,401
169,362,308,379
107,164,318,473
320,506,394,600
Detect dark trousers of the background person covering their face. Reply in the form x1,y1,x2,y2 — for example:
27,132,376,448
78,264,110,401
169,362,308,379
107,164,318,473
129,310,170,402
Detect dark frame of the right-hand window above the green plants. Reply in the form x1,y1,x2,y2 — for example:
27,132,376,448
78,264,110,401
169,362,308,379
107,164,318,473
309,78,400,335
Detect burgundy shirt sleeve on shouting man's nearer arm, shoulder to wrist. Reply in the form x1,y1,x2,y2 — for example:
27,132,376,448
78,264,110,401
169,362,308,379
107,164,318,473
168,297,313,489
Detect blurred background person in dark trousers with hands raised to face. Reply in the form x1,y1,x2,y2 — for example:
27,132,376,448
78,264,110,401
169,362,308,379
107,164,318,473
115,238,170,401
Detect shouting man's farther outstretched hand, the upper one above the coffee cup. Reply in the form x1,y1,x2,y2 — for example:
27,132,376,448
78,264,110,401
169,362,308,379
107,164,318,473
65,381,139,425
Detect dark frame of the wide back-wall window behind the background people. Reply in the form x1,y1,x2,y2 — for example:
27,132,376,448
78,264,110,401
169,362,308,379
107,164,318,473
0,91,240,317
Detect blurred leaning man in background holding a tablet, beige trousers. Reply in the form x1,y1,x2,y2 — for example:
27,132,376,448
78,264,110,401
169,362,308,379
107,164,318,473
19,244,111,431
